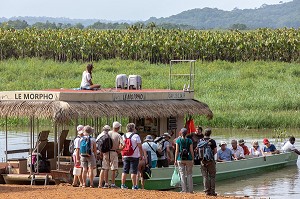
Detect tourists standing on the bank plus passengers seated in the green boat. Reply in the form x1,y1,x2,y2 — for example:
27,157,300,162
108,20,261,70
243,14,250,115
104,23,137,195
73,121,300,196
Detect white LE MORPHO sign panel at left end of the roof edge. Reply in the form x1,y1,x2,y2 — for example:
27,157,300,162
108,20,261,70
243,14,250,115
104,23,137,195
0,92,59,101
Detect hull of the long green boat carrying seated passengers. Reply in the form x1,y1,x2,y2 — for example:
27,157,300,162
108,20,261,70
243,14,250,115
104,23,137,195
94,152,298,190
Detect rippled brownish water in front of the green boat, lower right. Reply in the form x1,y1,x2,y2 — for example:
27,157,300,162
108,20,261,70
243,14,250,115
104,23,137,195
209,165,300,198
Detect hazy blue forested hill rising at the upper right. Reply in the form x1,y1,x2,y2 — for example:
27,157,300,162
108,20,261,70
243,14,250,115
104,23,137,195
146,0,300,29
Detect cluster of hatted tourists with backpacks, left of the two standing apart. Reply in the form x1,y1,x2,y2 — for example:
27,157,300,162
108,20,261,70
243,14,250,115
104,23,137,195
73,121,171,189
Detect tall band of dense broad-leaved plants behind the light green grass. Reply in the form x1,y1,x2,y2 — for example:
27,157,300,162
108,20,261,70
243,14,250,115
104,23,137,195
0,26,300,63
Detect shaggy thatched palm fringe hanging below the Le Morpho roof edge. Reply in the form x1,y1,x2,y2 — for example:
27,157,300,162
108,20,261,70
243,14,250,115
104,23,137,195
0,99,213,123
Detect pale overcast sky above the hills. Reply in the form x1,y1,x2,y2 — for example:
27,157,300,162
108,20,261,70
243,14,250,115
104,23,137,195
0,0,291,20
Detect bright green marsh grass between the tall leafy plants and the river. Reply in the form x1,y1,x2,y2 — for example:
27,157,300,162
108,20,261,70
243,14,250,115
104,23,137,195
0,58,300,128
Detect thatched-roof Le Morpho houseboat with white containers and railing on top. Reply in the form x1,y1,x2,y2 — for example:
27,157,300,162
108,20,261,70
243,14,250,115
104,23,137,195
0,60,213,186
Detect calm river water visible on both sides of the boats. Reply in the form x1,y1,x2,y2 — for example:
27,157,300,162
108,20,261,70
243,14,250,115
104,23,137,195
0,129,300,199
